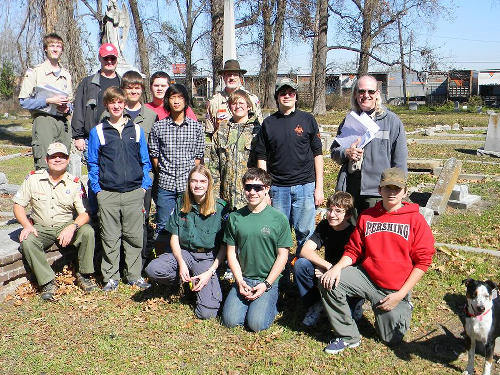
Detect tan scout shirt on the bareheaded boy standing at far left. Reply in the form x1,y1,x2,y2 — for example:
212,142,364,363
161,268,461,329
19,60,73,101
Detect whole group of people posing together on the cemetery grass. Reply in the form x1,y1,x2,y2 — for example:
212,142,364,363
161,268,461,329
14,34,434,353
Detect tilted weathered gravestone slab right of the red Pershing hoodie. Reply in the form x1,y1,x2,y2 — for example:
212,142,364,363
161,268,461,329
426,158,462,215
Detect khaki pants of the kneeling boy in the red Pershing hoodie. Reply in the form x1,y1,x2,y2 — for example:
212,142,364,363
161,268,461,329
319,266,413,345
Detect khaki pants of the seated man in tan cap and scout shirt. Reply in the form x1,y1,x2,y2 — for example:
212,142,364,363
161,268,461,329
21,221,95,285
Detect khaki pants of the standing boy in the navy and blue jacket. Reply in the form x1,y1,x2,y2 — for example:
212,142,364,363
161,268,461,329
97,188,144,283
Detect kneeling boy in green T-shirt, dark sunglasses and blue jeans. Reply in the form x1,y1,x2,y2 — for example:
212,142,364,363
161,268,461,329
222,168,293,332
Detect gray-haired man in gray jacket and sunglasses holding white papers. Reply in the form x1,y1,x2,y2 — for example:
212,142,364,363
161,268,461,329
330,75,408,217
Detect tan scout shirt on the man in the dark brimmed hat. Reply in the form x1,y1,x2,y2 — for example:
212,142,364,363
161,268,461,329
205,88,263,134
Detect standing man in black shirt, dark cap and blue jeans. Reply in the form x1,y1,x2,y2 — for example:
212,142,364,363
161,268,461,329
255,78,324,255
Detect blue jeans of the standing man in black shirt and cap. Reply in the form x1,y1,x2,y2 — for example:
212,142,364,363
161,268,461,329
271,182,316,255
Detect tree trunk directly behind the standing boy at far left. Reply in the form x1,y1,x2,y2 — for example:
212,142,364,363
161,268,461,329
41,0,87,87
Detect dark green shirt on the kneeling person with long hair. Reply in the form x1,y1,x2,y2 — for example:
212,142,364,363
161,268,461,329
165,198,229,250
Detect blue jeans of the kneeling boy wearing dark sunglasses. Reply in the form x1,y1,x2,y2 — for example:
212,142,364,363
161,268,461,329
222,278,279,332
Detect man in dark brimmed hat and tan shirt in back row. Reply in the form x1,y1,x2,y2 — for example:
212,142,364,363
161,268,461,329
205,60,262,137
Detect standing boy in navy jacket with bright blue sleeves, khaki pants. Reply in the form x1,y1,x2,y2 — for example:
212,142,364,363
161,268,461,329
88,86,151,292
